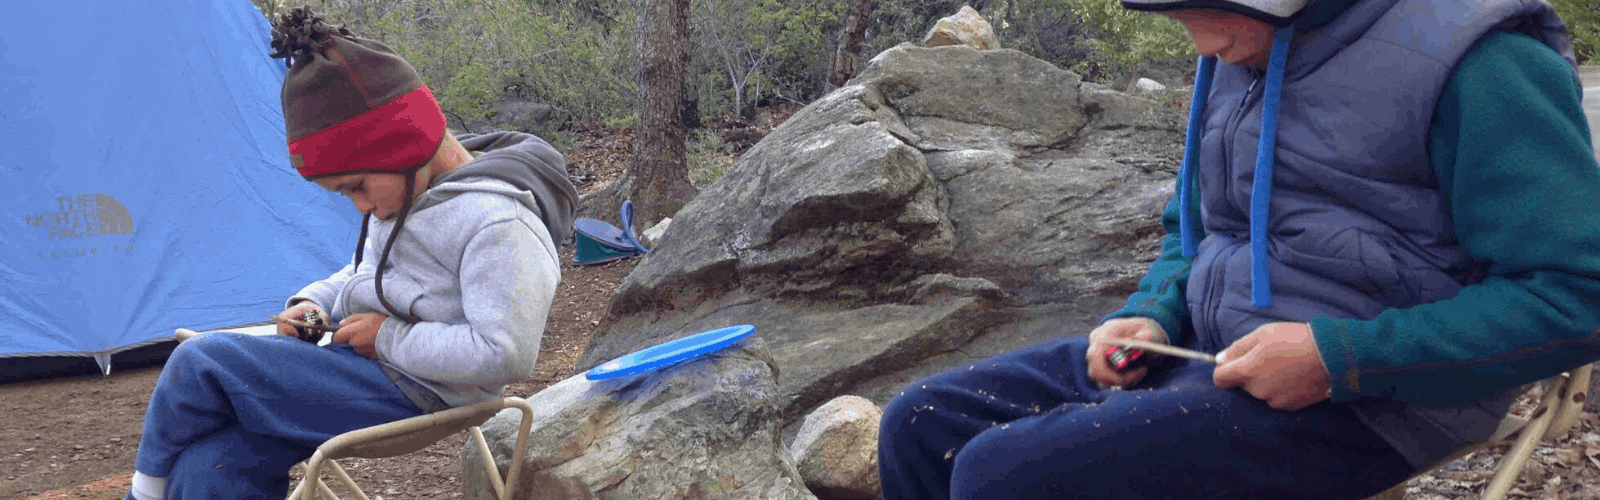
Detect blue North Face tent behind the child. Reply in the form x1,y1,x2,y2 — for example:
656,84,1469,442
0,0,360,381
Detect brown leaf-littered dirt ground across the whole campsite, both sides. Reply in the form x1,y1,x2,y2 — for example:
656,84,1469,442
0,111,1600,500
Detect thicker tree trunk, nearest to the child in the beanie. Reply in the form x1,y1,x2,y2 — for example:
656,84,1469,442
579,0,698,232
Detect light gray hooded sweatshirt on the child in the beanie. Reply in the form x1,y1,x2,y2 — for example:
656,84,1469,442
288,131,578,412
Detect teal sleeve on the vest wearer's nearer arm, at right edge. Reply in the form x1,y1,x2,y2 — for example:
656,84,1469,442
1310,32,1600,404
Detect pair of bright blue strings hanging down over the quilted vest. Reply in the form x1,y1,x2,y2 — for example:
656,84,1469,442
1178,26,1294,308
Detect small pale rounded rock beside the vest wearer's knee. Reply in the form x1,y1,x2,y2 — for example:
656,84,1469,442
789,396,883,500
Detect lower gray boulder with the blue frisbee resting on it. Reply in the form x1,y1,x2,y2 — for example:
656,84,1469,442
462,338,816,500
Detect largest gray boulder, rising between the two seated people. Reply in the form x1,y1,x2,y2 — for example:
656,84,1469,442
579,45,1182,431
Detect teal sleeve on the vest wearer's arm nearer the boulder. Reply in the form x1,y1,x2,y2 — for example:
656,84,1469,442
1102,169,1205,346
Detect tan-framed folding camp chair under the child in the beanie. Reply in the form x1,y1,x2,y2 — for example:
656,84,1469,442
174,329,533,500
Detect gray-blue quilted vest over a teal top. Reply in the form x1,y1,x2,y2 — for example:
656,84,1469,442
1179,0,1578,466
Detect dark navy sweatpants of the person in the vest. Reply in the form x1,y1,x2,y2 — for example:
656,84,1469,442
878,337,1414,500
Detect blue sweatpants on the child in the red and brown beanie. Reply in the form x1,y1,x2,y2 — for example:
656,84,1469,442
134,333,422,500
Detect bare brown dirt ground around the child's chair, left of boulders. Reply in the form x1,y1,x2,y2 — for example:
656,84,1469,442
0,248,637,500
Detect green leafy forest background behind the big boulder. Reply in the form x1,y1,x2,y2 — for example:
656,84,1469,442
253,0,1600,184
